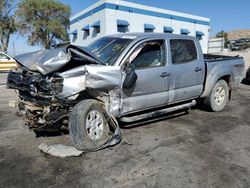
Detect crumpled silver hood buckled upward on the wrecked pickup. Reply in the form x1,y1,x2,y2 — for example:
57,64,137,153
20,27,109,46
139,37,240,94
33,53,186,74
15,45,103,75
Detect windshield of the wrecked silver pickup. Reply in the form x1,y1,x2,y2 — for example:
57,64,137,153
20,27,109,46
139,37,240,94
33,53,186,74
88,37,132,65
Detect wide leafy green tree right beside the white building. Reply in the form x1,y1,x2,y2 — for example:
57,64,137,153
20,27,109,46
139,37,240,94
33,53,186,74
16,0,71,49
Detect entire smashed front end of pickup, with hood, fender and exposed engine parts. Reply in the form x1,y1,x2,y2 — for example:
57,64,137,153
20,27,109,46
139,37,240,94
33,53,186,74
7,45,124,131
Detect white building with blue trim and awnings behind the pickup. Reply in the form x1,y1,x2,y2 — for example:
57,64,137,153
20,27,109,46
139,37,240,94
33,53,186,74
70,0,210,53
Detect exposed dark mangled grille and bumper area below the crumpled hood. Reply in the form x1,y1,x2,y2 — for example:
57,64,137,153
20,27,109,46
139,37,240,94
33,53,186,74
7,69,74,131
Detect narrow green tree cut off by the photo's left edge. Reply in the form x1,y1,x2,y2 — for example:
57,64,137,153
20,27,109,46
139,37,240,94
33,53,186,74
0,0,17,53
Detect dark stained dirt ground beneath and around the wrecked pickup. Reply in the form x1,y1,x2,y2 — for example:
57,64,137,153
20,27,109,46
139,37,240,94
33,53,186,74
0,74,250,188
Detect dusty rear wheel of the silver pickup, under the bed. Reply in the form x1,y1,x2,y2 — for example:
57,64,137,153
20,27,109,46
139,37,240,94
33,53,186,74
205,80,229,112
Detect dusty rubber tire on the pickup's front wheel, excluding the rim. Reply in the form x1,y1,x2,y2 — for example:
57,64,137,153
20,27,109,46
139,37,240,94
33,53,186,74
69,99,110,151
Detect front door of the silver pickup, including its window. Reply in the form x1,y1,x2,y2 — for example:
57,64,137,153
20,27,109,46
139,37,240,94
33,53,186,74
121,40,169,114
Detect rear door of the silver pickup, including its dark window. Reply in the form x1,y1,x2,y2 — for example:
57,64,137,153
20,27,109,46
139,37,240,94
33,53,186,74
166,39,205,103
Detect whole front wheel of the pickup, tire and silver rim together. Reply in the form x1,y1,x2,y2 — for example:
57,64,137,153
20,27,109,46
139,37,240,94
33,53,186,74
69,99,110,151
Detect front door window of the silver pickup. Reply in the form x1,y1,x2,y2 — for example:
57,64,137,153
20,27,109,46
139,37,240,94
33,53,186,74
129,40,166,69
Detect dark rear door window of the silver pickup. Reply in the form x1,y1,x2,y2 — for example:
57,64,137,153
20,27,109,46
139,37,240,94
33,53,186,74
170,40,197,64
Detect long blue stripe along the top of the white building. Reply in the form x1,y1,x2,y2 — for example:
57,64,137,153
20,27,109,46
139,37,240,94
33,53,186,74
70,3,209,25
